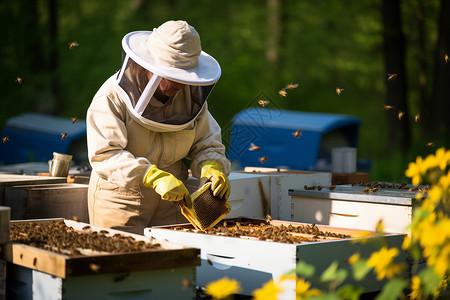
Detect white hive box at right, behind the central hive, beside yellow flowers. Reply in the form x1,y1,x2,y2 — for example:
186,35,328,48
289,185,415,233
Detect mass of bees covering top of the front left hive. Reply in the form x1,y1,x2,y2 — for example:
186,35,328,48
10,220,161,256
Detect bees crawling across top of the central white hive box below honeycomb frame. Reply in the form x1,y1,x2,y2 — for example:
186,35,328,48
173,216,351,244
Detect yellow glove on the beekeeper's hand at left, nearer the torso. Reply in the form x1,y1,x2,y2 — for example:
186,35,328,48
143,165,191,202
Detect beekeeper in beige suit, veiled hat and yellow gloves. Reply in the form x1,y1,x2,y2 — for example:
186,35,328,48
86,21,230,234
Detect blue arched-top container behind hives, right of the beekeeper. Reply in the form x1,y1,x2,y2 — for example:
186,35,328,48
227,108,361,171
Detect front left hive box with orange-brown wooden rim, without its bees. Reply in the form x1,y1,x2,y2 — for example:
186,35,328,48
4,219,200,299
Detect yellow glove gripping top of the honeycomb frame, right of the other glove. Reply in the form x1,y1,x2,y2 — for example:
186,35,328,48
200,161,231,200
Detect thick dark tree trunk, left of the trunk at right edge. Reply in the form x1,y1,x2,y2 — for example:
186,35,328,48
382,0,411,153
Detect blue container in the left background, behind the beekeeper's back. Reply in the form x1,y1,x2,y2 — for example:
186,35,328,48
0,113,87,165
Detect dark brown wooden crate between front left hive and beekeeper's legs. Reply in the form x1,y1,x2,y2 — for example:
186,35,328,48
5,183,89,223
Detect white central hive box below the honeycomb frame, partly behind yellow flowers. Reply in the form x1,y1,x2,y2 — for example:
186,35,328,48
144,218,406,299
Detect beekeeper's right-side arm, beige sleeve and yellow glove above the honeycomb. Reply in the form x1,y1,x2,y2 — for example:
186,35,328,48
189,105,230,199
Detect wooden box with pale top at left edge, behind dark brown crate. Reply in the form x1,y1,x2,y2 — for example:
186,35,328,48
0,174,67,206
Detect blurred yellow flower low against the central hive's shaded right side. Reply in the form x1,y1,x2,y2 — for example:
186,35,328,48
367,247,403,280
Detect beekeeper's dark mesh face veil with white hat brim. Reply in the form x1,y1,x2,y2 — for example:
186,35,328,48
115,32,220,131
